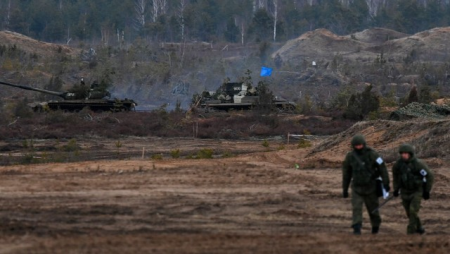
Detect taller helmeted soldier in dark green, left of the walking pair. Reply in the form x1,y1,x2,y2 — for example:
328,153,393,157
342,135,390,235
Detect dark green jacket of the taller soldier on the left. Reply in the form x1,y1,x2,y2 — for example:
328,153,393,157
342,147,389,194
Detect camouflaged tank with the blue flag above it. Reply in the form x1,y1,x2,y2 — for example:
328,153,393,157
193,82,296,112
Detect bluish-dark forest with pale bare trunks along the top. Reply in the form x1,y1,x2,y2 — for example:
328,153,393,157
0,0,450,45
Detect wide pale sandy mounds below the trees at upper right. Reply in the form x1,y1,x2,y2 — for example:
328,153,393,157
272,27,450,63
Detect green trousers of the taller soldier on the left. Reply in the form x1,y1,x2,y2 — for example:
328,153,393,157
352,190,381,227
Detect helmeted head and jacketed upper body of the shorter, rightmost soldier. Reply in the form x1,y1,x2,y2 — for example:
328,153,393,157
392,145,434,195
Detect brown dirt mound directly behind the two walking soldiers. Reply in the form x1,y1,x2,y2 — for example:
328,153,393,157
305,120,450,167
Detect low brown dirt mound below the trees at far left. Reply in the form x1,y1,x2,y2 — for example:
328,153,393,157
0,31,81,57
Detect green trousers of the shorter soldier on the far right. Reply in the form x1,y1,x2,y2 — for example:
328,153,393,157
402,191,422,234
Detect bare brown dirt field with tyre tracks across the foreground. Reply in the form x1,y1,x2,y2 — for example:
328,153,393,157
0,140,450,253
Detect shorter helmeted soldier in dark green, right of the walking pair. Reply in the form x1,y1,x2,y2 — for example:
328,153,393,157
392,144,434,234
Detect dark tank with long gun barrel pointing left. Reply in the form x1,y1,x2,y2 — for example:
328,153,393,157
0,81,137,112
